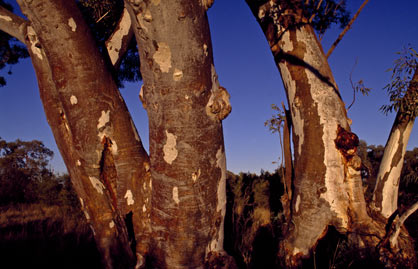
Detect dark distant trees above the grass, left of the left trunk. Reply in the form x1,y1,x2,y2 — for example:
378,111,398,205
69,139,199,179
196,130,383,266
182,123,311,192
0,139,79,210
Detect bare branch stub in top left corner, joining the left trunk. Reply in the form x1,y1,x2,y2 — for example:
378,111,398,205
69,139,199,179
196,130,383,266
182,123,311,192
0,6,27,43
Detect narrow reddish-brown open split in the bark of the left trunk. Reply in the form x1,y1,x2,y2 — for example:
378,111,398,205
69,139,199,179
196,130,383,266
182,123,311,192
100,136,117,209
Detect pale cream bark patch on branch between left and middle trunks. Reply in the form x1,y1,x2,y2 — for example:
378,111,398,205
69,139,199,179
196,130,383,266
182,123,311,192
106,8,131,65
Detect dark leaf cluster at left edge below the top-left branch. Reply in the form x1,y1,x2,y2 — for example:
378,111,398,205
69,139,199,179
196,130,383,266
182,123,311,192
0,0,29,87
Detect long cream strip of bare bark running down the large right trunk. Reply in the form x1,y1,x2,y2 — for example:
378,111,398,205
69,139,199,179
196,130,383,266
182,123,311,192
296,27,349,227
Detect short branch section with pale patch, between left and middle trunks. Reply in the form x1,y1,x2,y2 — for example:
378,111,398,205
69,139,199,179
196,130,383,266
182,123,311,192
106,8,133,69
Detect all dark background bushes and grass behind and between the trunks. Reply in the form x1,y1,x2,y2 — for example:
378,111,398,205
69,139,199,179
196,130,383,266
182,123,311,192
0,139,418,268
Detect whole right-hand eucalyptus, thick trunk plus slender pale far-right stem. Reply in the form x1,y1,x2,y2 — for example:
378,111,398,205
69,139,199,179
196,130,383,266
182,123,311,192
246,0,417,267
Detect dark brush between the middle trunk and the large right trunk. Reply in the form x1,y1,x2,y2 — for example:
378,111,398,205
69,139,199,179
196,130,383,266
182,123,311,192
225,170,283,268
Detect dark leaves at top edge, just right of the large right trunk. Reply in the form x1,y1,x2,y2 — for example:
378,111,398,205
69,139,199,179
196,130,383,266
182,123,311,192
301,0,350,37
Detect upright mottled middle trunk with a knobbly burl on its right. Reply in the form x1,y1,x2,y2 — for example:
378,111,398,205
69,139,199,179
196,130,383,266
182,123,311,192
125,0,235,268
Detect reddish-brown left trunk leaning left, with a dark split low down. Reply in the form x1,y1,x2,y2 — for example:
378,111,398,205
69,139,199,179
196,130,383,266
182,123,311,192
10,0,151,268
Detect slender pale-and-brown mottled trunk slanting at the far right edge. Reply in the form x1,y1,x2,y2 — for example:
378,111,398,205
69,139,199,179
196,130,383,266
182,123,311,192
371,69,418,218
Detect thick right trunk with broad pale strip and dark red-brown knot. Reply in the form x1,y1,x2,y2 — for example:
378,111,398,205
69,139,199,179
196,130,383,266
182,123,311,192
247,0,414,267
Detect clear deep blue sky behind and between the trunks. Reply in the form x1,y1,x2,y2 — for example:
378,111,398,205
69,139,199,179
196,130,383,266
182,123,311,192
0,0,418,173
